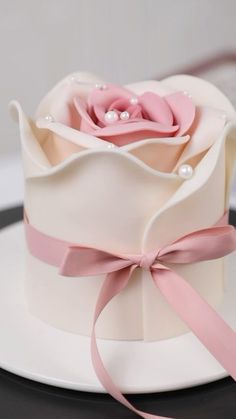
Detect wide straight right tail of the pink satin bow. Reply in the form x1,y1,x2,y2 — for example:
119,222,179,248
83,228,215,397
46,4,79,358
151,267,236,380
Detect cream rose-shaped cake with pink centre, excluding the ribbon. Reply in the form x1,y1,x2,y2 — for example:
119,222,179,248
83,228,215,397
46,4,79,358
11,73,236,340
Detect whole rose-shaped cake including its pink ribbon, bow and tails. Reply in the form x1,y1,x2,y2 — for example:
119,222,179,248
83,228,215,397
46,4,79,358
11,73,236,417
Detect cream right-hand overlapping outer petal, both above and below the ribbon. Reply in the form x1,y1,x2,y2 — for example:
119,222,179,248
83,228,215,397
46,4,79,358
142,124,236,340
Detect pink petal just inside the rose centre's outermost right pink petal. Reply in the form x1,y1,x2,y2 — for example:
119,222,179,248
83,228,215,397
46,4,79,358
139,92,173,126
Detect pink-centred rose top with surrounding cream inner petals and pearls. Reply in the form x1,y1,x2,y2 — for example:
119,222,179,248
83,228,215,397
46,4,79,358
13,73,228,173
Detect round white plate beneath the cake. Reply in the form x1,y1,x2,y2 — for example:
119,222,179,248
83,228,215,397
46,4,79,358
0,223,236,393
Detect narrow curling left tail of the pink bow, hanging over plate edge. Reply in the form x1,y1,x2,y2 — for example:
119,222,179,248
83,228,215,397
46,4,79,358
91,265,171,419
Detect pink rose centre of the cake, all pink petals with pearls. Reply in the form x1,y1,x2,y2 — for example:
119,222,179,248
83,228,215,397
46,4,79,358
74,84,195,146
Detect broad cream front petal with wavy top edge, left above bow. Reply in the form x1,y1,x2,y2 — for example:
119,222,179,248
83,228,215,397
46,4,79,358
25,150,183,253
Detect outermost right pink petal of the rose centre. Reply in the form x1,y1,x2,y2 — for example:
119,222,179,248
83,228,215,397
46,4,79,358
165,92,195,136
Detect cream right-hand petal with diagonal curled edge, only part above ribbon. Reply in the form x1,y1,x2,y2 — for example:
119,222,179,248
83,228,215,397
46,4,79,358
143,123,236,251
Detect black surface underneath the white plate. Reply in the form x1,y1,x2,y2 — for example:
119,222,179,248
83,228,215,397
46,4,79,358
0,207,236,419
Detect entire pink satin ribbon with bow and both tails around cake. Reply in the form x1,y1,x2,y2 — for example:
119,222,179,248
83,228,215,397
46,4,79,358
25,214,236,419
